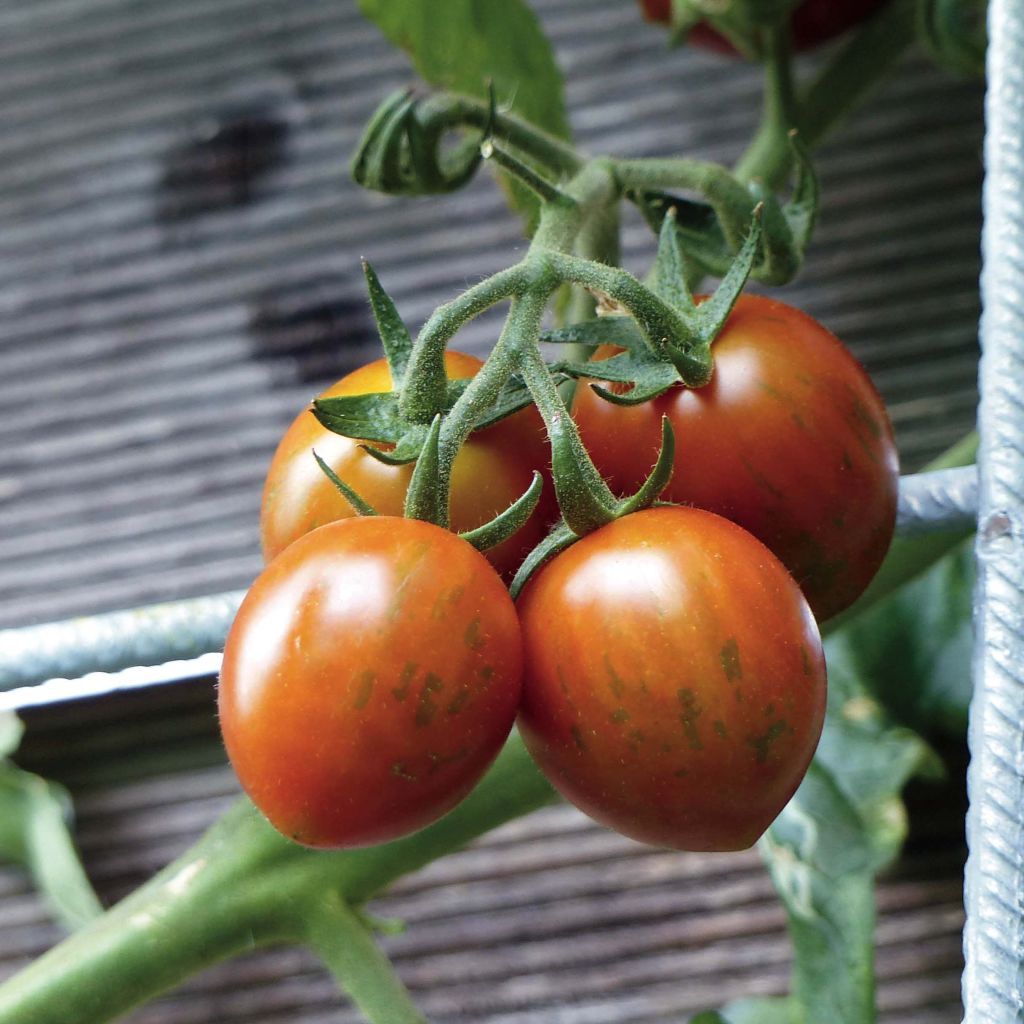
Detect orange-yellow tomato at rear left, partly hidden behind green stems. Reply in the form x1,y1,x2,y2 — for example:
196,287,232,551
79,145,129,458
260,352,557,579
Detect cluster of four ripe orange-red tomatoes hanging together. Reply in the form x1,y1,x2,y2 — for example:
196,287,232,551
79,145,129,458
219,296,897,850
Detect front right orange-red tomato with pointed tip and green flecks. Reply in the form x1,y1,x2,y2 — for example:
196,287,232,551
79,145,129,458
518,507,825,850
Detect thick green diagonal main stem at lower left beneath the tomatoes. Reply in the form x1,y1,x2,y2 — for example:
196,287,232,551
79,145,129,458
0,736,554,1024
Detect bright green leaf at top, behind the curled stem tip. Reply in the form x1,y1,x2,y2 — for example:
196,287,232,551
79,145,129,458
359,0,570,225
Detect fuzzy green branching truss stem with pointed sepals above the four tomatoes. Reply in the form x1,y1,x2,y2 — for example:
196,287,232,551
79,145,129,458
335,90,818,586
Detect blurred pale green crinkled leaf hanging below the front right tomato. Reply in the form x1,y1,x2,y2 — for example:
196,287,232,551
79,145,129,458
691,610,942,1024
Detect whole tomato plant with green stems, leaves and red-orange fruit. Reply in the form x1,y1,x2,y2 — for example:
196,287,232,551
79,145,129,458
0,0,983,1024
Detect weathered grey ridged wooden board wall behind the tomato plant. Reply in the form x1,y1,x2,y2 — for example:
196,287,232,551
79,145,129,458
0,0,982,1024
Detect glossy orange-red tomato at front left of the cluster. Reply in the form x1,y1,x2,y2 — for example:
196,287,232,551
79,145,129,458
218,517,522,848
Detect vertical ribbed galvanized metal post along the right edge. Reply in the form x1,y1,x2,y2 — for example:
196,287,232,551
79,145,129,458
964,0,1024,1024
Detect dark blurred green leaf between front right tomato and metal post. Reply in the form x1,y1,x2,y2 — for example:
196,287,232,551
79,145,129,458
826,540,975,736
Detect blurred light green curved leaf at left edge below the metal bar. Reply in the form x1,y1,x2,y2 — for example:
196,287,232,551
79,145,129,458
0,762,102,930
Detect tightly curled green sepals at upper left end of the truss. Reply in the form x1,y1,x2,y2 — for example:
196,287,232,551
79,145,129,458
352,90,495,196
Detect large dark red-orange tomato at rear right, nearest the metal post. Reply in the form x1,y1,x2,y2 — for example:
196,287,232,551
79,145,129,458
573,295,899,622
